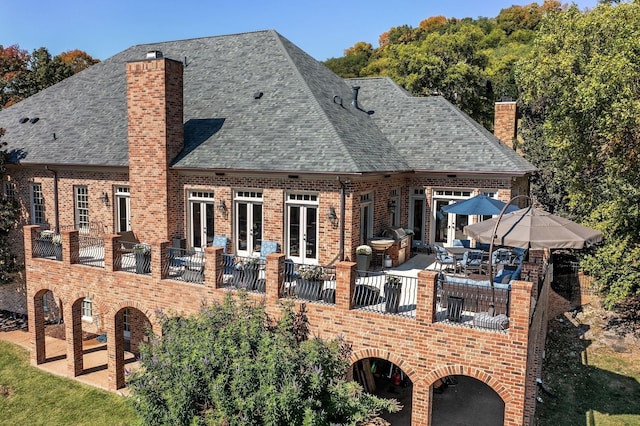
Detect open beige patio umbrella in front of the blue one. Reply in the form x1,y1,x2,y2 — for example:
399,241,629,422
464,207,602,249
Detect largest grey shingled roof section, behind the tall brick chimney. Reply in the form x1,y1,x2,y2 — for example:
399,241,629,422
0,31,409,173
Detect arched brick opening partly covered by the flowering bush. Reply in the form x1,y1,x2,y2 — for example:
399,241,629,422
105,300,159,390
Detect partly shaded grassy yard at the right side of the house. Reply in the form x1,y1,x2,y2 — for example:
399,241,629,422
536,300,640,426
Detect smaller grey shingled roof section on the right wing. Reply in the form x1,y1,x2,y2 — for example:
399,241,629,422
347,78,536,175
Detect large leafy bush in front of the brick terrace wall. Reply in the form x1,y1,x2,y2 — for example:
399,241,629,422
129,294,399,425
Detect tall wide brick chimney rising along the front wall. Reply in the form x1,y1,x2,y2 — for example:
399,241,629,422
127,52,184,244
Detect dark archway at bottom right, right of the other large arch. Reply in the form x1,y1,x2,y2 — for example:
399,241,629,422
431,375,505,426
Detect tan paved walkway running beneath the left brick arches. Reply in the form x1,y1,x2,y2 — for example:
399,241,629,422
0,330,139,395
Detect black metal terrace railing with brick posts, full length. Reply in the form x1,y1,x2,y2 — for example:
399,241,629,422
30,227,547,332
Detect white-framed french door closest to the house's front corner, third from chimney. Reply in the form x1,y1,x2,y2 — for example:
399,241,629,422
286,194,318,264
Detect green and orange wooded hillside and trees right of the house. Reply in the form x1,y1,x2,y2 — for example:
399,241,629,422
325,0,640,308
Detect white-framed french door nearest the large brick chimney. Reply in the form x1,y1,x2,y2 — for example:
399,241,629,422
189,191,215,251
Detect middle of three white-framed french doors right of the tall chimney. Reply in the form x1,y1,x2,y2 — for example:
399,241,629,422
234,191,263,256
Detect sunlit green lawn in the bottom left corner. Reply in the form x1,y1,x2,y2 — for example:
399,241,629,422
0,341,139,426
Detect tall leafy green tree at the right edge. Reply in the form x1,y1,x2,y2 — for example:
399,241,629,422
517,2,640,307
